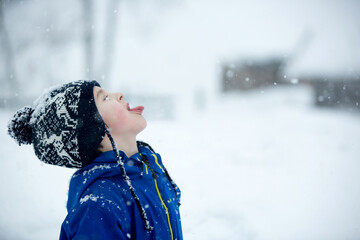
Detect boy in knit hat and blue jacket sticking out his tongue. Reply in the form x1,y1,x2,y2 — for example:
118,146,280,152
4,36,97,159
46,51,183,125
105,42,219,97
8,81,182,240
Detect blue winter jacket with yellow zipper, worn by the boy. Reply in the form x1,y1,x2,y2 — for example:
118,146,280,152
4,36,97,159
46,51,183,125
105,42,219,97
60,146,183,240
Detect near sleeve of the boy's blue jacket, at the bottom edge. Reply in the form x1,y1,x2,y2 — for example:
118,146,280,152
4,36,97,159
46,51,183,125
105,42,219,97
60,200,131,240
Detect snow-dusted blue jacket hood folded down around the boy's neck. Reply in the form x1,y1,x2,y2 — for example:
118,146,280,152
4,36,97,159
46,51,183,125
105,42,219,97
67,142,155,212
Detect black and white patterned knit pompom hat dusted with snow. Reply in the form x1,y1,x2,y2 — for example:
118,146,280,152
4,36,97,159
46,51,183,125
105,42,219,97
8,80,106,168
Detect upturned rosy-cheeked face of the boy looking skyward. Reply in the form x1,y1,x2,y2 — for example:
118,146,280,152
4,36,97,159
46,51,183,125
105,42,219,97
94,86,147,136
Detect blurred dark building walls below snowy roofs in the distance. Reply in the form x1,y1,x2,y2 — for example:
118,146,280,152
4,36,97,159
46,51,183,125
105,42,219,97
221,58,360,110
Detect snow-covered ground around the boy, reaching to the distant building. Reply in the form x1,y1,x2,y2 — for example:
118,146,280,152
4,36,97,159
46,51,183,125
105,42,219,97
0,86,360,240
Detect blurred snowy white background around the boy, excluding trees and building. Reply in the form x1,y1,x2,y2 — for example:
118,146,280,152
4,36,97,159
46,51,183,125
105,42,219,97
0,0,360,240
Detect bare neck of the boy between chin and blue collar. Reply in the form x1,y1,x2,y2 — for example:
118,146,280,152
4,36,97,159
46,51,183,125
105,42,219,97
102,136,139,157
